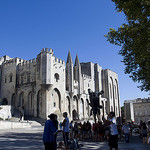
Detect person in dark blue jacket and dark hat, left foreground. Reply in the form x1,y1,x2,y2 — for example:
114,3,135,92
43,113,57,150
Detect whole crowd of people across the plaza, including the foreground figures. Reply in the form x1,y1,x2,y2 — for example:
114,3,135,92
43,112,150,150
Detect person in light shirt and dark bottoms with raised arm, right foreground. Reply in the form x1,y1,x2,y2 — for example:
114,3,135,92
102,112,118,150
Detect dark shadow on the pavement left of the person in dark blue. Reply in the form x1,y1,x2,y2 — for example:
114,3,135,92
0,132,44,150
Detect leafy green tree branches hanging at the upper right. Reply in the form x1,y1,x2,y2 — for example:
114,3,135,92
105,0,150,91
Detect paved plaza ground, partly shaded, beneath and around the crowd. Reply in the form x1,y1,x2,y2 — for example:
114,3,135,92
0,126,150,150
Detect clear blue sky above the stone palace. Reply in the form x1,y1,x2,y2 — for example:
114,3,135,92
0,0,150,106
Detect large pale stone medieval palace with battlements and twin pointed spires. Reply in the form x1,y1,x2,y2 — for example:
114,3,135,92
0,48,120,120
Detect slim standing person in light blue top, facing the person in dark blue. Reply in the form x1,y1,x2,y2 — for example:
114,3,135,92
62,112,69,149
